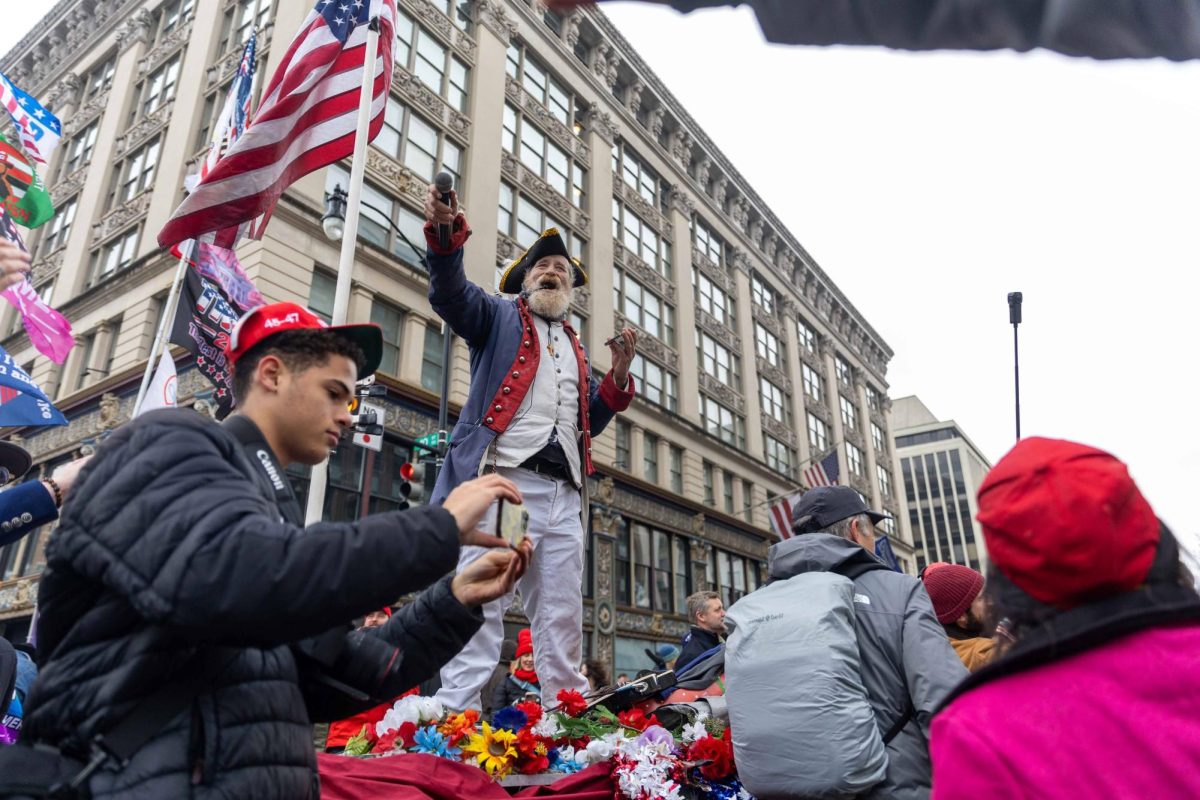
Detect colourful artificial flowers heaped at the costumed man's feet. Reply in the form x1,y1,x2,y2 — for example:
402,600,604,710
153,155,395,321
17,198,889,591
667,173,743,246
346,690,752,800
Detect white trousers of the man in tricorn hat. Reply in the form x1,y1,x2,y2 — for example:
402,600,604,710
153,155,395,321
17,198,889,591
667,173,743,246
437,467,588,711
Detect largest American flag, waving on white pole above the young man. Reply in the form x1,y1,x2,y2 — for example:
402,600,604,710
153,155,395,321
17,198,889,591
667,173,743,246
158,0,396,248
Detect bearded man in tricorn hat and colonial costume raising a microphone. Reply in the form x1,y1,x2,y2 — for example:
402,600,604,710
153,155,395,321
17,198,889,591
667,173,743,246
425,186,637,710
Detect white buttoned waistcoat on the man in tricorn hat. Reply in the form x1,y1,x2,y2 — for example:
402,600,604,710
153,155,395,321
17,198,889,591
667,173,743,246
496,314,581,486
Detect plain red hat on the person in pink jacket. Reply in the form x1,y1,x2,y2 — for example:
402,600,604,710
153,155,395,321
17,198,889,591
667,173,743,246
978,437,1159,608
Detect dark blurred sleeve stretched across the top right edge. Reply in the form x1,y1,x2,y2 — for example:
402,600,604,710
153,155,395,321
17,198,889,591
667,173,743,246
548,0,1200,61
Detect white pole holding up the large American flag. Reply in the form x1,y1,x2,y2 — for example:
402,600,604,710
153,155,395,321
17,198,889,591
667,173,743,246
304,17,381,525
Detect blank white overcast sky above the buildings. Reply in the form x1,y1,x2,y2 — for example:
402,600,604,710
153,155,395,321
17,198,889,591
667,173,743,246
0,2,1200,544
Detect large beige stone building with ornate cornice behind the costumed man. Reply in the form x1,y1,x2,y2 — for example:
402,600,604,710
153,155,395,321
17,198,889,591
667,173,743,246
0,0,913,670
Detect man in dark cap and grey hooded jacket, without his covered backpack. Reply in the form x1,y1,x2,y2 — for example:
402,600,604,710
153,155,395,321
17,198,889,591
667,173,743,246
768,486,967,800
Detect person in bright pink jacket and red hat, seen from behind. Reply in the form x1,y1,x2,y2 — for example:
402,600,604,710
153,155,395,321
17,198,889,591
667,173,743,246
930,438,1200,800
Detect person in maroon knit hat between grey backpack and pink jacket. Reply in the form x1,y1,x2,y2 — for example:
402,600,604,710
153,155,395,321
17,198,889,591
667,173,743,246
920,561,995,672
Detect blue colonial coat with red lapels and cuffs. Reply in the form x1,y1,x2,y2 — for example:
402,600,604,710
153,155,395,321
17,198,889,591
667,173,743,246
425,225,634,503
